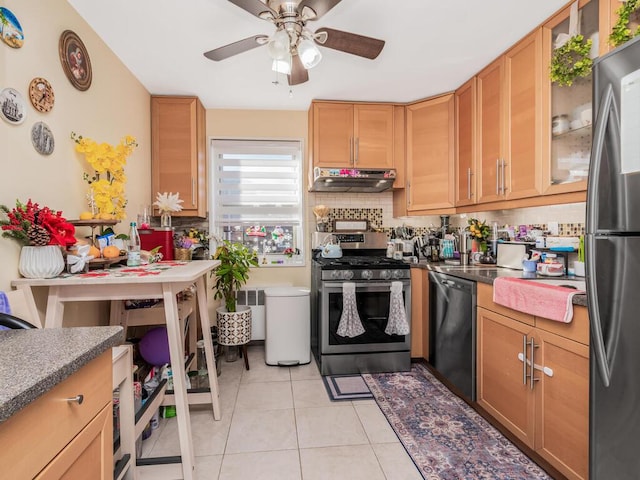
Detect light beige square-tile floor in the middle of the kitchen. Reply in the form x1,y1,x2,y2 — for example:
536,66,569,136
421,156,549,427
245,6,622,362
139,345,422,480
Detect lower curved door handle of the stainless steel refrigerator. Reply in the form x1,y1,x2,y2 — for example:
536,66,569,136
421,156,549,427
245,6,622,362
585,235,611,387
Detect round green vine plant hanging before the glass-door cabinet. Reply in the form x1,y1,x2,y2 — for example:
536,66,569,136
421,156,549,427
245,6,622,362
549,35,593,87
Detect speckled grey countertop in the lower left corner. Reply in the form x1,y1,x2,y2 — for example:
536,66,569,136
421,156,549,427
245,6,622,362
0,326,124,423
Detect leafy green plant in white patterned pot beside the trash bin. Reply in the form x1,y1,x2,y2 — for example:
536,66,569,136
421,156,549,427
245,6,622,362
212,240,258,370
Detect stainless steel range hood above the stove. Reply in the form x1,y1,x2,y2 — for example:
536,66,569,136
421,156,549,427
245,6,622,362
309,167,396,193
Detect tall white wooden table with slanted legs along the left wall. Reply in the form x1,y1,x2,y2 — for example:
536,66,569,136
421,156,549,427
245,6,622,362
11,260,220,480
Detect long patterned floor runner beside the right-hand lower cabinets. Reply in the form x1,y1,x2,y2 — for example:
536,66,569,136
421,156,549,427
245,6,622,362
362,364,551,480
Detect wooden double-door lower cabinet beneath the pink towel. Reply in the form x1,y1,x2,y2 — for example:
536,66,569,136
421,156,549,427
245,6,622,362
477,307,589,479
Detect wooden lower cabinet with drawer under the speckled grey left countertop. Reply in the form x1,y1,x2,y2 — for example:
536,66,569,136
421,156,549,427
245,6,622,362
0,349,113,480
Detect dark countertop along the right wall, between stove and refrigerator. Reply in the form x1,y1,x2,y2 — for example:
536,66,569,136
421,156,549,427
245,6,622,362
411,260,587,307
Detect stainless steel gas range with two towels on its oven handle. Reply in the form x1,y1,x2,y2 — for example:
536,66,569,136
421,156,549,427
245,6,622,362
311,232,411,375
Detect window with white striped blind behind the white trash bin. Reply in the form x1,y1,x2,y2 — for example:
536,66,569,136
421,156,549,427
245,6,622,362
210,140,304,266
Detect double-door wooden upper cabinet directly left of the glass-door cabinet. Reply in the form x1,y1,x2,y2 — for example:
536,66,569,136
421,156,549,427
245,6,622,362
477,30,542,203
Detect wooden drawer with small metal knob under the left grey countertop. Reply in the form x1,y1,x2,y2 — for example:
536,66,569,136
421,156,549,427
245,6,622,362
0,349,112,478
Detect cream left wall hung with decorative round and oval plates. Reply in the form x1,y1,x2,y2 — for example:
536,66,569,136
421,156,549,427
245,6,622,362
0,0,151,318
